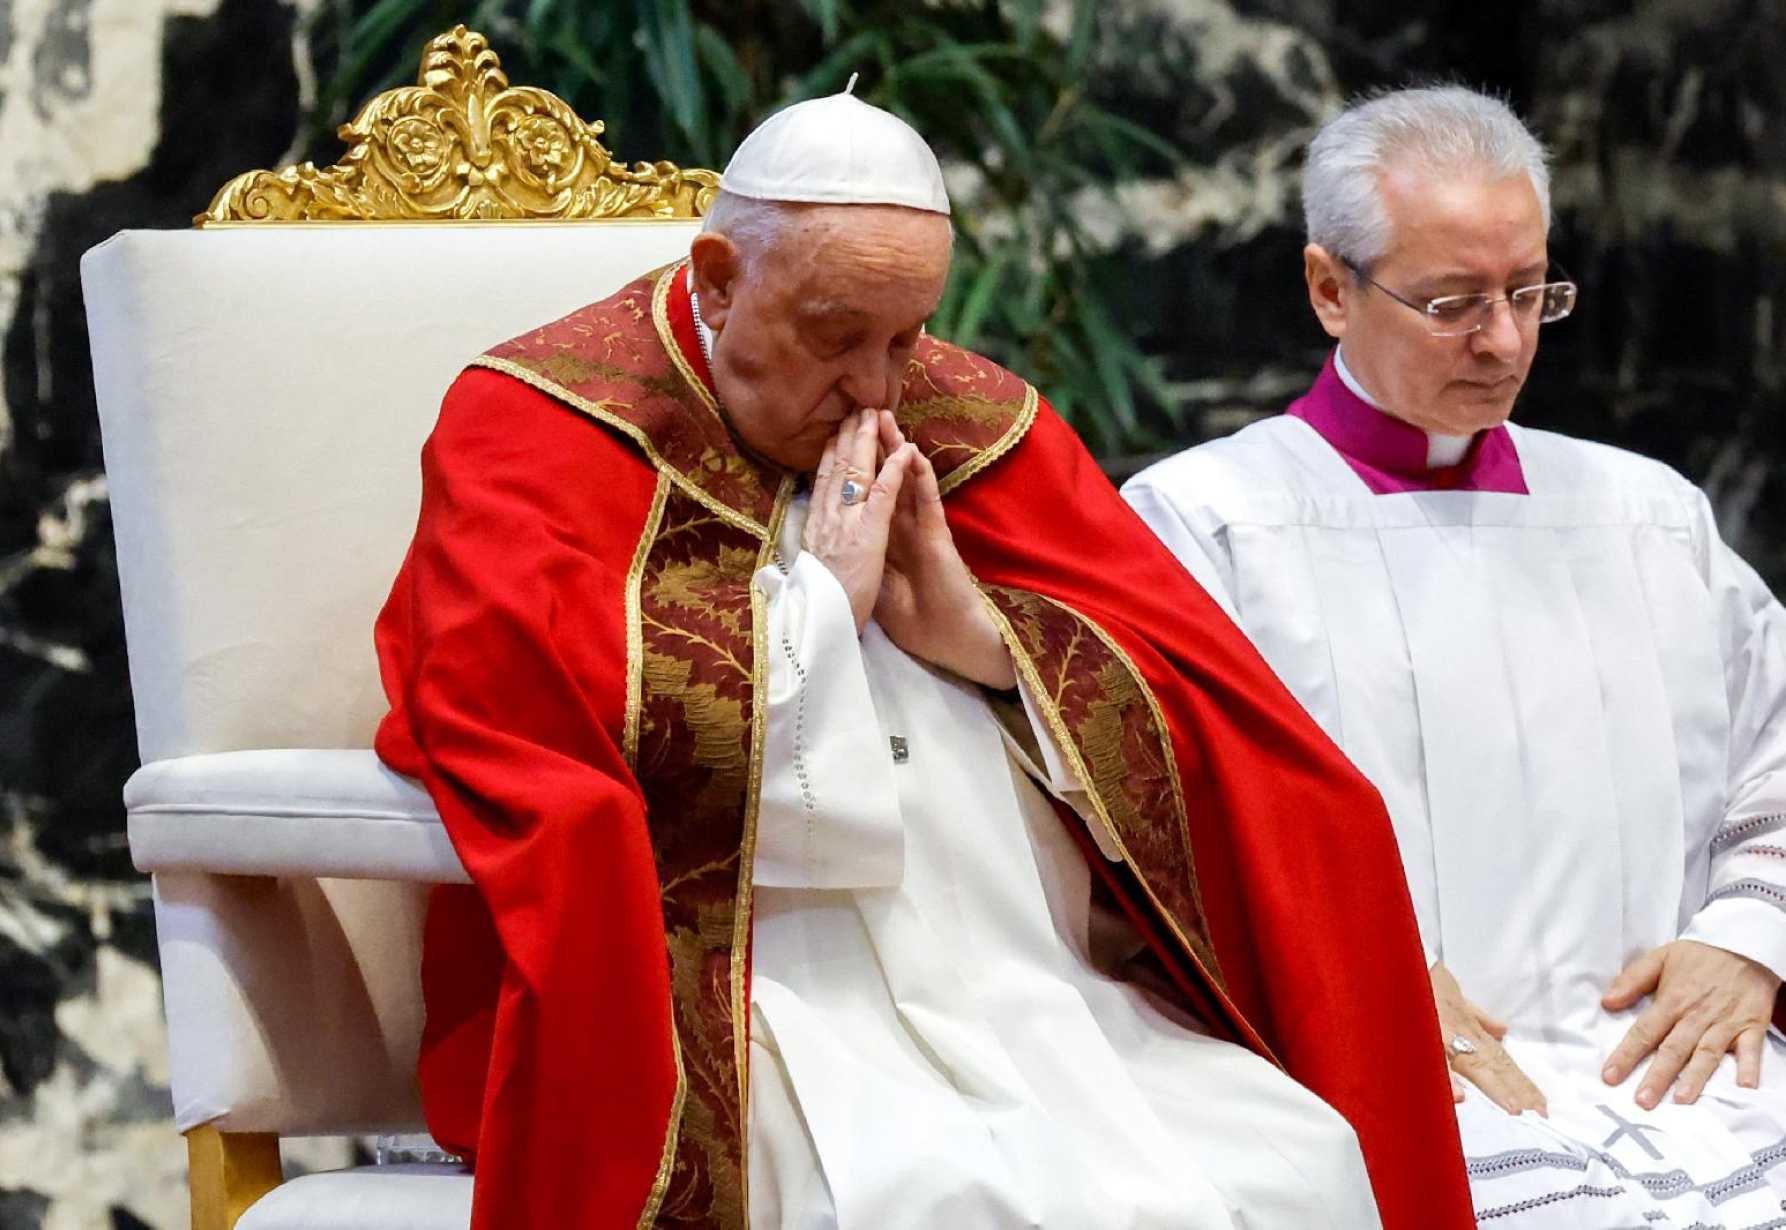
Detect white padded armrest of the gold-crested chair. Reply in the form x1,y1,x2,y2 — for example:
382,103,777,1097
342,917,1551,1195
123,748,470,884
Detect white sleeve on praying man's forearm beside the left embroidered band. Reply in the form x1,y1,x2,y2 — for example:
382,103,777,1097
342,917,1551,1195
752,553,906,889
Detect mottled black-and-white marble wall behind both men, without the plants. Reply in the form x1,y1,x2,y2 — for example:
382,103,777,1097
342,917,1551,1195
0,0,1786,1230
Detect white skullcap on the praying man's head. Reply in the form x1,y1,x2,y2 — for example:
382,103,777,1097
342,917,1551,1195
720,77,948,214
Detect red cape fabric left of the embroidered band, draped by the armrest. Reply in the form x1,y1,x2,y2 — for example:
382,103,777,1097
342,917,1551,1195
377,370,677,1230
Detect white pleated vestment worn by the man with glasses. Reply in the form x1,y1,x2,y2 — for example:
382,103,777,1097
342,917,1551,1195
1123,416,1786,1230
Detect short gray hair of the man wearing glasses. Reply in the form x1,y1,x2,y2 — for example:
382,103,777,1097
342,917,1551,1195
1302,86,1550,268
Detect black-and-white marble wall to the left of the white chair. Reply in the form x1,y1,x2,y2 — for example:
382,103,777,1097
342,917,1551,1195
0,0,344,1230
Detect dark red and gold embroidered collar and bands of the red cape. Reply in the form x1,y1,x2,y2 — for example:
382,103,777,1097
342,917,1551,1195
473,262,1275,1230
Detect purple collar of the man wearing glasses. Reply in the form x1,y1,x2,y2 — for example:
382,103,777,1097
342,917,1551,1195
1286,355,1529,496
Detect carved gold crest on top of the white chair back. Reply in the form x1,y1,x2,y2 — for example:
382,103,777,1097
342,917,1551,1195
193,25,720,227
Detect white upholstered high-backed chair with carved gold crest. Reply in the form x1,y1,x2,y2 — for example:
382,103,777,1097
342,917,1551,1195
82,27,716,1230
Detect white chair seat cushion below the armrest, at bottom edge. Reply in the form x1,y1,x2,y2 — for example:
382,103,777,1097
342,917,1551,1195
236,1166,472,1230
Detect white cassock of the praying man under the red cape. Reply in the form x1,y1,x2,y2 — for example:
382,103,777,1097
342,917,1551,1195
748,498,1379,1230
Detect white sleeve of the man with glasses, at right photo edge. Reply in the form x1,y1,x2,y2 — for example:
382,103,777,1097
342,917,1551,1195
1681,496,1786,977
